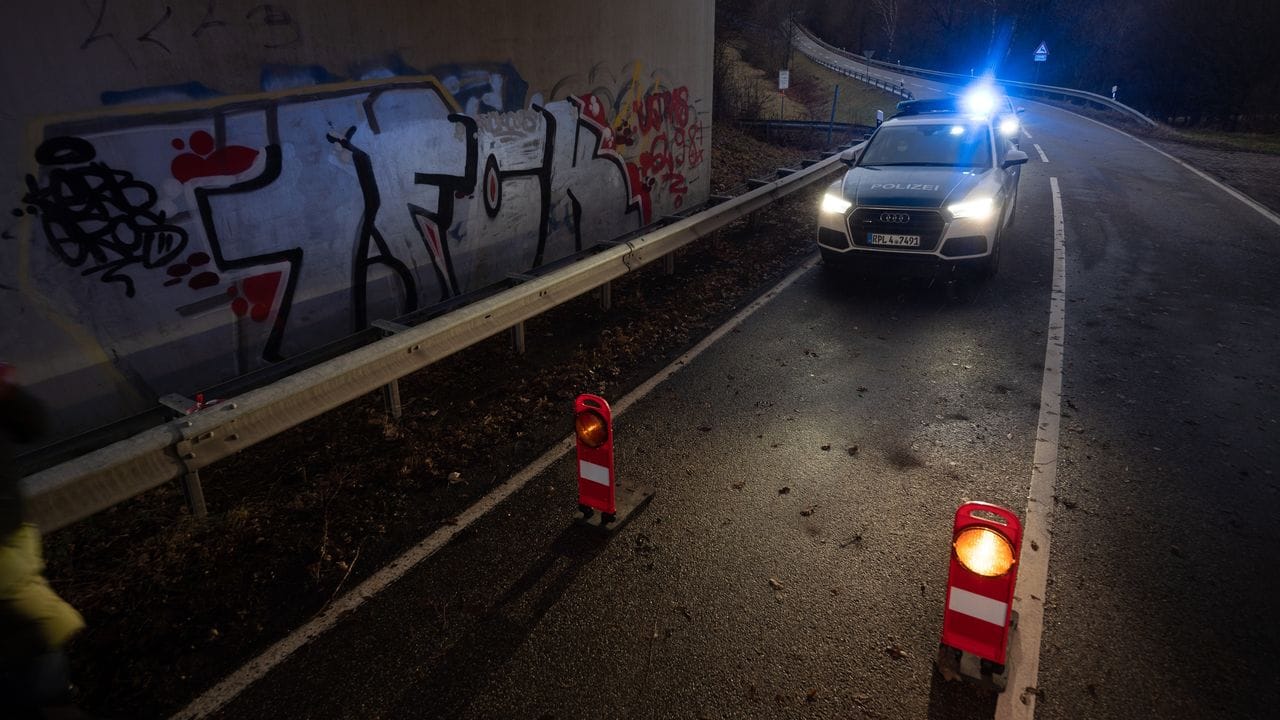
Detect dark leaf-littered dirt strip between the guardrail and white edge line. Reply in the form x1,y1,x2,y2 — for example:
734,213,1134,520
40,120,824,717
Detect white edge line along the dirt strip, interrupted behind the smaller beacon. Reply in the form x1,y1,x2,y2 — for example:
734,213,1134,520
173,258,818,720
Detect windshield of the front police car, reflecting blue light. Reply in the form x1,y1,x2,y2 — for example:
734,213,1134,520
860,123,991,168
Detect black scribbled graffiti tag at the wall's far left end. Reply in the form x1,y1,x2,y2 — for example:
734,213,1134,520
22,137,187,297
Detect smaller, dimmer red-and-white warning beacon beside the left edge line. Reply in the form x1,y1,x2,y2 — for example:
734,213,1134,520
573,395,653,529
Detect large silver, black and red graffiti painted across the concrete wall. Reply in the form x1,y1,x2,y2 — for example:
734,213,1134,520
14,68,708,425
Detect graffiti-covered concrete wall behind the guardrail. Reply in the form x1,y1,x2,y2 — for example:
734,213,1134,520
0,0,713,436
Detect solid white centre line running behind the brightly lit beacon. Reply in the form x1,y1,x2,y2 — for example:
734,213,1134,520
996,177,1066,720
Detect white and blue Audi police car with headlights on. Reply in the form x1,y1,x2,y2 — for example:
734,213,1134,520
818,92,1027,278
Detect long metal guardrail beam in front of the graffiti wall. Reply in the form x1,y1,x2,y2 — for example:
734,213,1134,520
22,148,855,532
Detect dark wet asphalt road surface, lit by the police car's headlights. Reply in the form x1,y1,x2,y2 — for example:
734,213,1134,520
185,60,1280,719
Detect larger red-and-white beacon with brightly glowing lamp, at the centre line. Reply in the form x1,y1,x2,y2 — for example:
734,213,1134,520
938,502,1023,692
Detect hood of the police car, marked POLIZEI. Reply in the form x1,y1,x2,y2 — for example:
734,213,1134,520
841,167,992,208
